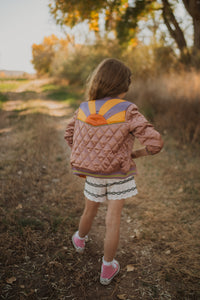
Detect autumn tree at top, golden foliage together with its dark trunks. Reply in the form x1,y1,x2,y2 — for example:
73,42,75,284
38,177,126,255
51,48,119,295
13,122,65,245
49,0,200,59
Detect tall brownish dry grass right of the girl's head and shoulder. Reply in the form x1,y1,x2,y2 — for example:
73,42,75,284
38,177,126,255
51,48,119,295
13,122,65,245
128,72,200,148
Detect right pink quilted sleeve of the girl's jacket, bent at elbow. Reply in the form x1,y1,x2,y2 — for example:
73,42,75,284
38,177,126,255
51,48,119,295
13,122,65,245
126,104,163,155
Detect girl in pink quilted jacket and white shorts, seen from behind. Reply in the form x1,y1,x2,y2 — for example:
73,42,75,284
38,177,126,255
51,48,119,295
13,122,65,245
65,59,163,285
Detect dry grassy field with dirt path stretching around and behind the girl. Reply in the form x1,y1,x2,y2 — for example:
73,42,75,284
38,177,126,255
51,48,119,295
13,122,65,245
0,79,200,300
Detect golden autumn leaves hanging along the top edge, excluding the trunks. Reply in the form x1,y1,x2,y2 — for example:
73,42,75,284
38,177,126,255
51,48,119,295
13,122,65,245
49,0,156,42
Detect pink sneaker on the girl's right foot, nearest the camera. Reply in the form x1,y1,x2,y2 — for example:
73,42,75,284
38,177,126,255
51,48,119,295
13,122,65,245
100,259,120,285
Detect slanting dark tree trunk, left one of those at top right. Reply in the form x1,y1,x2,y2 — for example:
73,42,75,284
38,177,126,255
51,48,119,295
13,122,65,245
162,0,187,55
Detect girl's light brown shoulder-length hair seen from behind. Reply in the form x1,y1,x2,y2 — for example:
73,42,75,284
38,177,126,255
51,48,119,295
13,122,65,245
86,58,131,100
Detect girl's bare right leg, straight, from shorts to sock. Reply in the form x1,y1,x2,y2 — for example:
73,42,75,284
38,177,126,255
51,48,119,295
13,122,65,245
104,199,124,262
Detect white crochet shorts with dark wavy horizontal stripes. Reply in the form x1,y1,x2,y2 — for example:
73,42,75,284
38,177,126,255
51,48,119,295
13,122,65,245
84,176,137,202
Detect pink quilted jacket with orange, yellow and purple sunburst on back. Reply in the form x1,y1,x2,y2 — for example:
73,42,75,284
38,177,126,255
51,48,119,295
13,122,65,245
65,98,163,178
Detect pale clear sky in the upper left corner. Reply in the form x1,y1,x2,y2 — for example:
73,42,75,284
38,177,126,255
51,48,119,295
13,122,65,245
0,0,64,73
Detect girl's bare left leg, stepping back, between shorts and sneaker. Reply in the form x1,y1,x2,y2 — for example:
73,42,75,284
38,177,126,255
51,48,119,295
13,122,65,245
79,198,100,238
